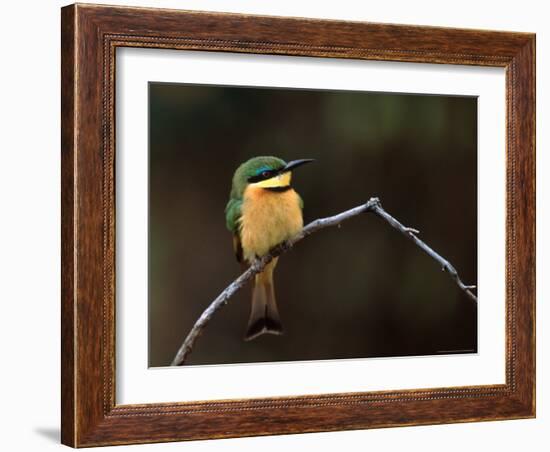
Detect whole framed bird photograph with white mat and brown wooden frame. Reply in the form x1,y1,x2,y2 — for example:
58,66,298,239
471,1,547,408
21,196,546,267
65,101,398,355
61,4,535,447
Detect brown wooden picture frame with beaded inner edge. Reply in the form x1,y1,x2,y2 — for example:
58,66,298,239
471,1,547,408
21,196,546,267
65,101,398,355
61,4,535,447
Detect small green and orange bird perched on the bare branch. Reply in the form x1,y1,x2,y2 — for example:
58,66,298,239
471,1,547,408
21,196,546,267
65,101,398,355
225,157,313,340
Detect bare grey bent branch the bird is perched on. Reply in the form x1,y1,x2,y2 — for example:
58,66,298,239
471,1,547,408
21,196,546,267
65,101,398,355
171,198,477,366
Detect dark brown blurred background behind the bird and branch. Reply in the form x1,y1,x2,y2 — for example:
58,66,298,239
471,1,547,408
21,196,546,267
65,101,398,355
149,83,477,366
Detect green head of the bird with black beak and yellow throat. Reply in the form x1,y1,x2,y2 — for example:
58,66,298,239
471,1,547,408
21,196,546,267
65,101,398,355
231,156,313,197
